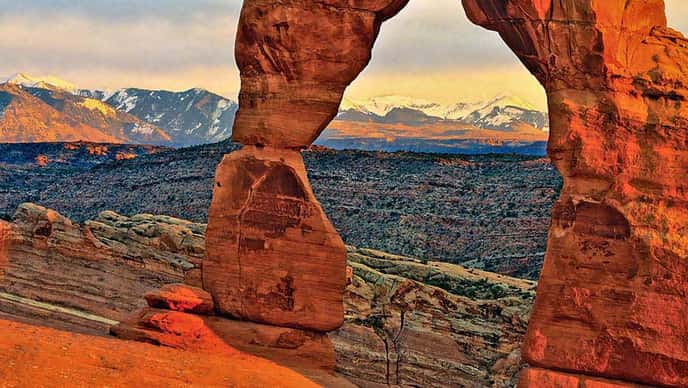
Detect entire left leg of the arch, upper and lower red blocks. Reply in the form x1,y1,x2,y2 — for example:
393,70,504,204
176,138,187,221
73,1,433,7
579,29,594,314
203,0,408,331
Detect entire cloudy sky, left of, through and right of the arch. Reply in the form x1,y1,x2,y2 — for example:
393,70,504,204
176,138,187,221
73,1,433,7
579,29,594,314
0,0,688,108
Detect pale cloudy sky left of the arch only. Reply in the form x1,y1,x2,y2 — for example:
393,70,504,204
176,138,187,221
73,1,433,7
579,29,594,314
0,0,240,94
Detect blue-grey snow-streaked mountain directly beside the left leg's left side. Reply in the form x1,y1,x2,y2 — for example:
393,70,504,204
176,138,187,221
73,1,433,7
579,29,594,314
104,89,238,146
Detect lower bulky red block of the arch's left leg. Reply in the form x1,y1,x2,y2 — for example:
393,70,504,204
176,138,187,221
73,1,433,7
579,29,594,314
203,146,346,331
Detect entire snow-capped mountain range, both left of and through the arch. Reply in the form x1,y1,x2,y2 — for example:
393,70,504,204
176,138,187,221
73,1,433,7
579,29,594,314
0,73,548,153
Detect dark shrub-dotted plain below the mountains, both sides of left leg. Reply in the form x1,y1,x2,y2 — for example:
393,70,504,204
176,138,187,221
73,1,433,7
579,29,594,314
0,143,561,279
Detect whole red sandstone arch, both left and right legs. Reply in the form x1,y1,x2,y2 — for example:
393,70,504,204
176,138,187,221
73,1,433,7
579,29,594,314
204,0,688,387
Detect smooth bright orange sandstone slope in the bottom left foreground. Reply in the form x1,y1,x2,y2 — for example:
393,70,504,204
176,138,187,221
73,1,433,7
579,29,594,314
0,320,326,388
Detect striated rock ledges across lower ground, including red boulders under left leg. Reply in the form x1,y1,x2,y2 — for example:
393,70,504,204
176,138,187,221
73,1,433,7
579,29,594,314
0,204,535,387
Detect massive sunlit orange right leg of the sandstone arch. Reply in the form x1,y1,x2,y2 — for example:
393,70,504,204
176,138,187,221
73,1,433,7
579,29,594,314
463,0,688,386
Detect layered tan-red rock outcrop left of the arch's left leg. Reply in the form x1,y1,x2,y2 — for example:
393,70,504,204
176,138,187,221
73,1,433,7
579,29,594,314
0,204,205,320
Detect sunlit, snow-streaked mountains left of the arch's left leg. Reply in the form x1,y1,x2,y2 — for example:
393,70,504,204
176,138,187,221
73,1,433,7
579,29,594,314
0,73,238,147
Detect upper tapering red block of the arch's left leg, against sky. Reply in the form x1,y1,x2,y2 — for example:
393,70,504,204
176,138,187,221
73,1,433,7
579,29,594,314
233,0,408,149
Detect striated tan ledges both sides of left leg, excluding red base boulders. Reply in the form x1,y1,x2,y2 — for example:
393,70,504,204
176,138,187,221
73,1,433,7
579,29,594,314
0,204,535,387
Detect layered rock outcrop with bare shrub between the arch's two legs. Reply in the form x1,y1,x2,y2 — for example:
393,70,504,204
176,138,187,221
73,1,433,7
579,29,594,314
330,248,535,387
